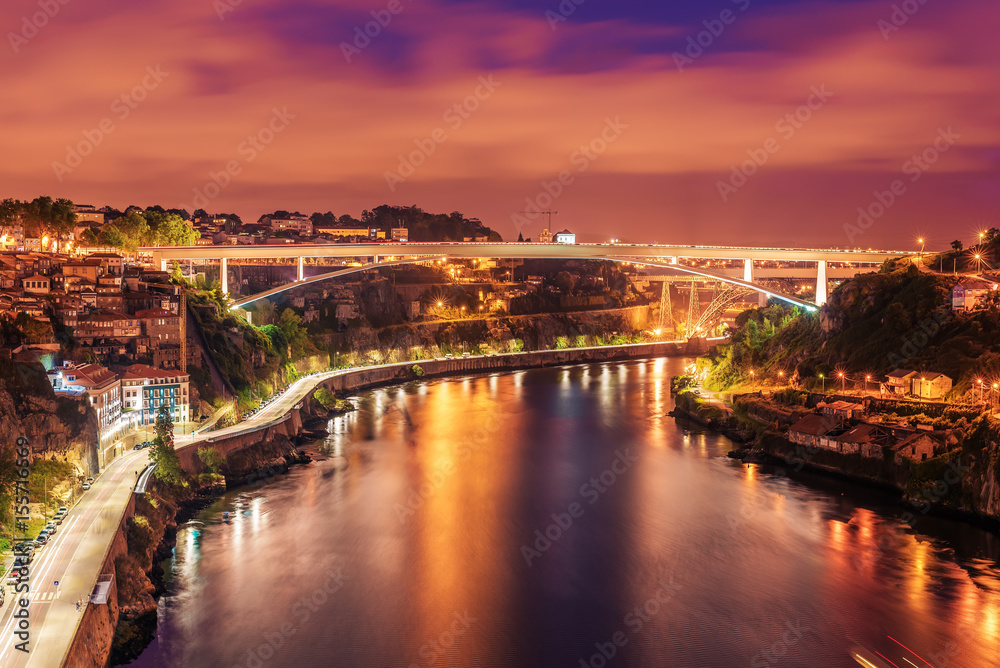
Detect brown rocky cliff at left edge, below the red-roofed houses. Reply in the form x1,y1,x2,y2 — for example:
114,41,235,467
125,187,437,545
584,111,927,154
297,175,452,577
0,362,98,474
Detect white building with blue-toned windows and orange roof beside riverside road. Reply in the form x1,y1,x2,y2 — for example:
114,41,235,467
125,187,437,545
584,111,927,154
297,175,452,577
121,364,191,426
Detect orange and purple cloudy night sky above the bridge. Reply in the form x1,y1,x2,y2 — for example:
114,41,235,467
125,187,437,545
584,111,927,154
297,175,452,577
0,0,1000,249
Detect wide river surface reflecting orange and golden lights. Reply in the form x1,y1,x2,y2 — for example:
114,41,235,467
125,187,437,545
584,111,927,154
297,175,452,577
133,358,1000,668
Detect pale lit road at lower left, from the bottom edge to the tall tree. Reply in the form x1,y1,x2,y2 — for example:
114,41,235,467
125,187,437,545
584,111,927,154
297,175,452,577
0,450,149,668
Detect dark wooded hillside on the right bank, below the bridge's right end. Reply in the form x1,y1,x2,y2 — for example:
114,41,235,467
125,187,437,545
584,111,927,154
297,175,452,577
702,264,1000,398
